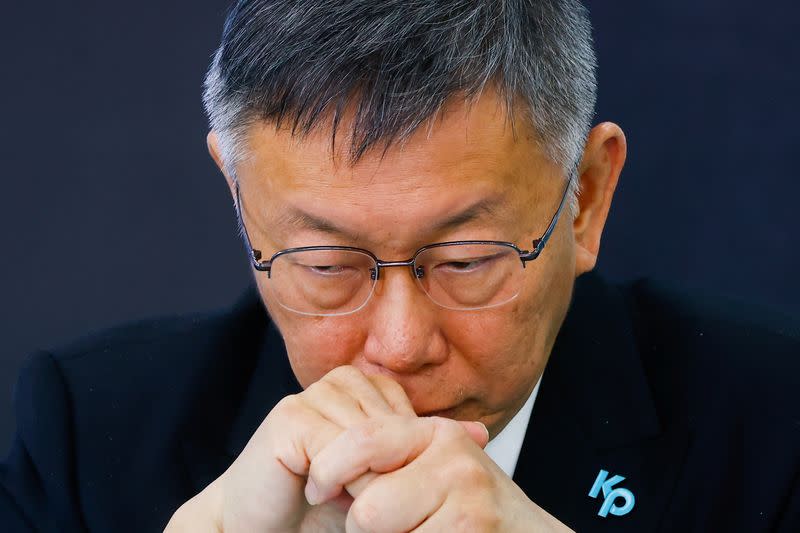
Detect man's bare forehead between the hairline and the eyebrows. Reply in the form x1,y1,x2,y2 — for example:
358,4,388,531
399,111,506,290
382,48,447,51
234,91,552,194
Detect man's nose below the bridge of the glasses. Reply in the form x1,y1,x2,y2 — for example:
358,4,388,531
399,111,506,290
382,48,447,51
364,267,447,374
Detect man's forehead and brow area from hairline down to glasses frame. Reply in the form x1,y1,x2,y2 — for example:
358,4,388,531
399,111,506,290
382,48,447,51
237,93,560,251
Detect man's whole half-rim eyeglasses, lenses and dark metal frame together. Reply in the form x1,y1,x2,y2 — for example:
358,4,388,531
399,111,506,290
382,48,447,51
234,168,577,316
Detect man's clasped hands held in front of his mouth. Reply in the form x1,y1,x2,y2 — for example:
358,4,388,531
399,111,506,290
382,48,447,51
165,366,570,533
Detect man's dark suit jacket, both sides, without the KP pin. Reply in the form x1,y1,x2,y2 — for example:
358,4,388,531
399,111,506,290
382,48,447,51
0,274,800,533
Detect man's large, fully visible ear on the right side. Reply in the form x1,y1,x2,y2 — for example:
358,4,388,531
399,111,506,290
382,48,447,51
573,122,627,277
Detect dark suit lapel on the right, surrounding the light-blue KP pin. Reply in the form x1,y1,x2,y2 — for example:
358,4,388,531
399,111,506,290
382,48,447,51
514,274,688,531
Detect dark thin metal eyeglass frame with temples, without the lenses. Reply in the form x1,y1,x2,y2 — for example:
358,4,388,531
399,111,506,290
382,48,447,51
233,165,578,282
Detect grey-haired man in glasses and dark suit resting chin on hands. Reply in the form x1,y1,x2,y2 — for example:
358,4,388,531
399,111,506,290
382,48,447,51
0,0,800,533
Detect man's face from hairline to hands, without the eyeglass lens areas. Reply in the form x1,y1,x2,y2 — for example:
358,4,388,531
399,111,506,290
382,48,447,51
228,92,576,436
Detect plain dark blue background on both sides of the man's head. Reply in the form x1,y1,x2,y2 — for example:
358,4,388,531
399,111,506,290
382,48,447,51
0,0,800,452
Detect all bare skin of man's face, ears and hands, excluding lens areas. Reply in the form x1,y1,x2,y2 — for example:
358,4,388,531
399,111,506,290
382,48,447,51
167,91,626,532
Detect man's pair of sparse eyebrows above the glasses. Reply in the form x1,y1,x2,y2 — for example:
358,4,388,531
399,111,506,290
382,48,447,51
278,194,504,241
